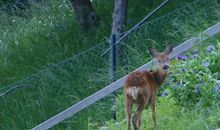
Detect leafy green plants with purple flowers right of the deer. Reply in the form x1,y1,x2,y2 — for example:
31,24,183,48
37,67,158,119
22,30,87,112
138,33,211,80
168,42,220,108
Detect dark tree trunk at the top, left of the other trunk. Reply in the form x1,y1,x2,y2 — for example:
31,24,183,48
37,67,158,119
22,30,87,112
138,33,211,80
71,0,99,31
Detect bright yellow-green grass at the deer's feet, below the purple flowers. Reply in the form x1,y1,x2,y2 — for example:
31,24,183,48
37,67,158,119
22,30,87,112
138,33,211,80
93,97,220,130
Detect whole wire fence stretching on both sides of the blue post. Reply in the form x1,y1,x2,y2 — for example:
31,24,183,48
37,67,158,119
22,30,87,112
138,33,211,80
0,0,219,129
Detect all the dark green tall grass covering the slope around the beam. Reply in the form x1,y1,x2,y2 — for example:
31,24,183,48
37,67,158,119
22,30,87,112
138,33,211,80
0,0,219,129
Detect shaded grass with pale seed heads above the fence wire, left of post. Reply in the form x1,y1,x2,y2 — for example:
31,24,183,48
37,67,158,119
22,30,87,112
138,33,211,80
0,1,112,86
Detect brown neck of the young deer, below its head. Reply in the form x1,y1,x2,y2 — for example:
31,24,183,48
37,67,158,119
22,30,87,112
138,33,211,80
153,69,167,87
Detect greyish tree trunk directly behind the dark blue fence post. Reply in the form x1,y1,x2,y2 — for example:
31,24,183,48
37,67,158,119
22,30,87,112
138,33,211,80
111,0,128,63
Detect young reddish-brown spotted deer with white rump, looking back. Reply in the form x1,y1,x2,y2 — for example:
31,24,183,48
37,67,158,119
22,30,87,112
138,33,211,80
124,44,173,130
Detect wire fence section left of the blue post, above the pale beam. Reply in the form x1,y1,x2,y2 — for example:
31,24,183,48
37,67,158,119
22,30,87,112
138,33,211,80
0,40,108,129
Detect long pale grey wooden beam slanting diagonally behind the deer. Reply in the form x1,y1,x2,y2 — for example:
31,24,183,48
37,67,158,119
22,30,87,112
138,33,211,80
32,23,220,130
